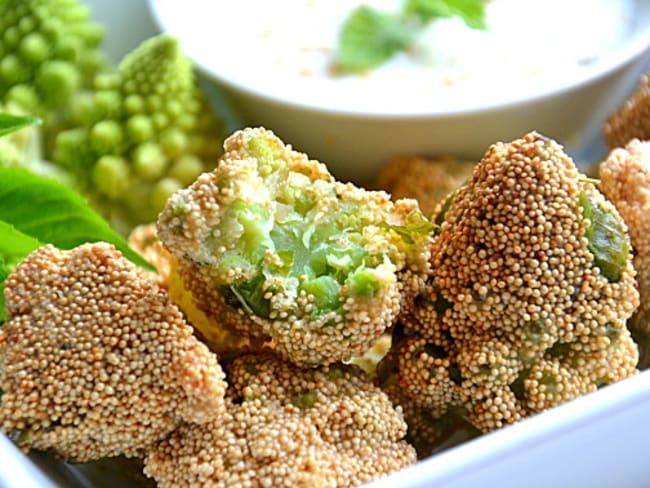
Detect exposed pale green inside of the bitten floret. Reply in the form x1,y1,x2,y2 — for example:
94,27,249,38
212,139,390,318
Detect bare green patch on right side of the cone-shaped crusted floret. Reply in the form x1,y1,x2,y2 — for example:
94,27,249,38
580,192,630,283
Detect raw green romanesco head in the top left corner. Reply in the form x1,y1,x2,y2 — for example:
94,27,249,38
0,0,104,125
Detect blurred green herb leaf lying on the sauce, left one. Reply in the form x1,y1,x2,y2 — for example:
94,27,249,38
336,6,418,71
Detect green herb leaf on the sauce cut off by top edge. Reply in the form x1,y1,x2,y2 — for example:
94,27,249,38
404,0,487,29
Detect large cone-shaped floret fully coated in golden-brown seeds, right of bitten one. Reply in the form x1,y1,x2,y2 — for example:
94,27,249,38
395,133,639,431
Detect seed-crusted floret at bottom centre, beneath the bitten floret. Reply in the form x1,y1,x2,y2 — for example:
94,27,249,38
145,353,415,488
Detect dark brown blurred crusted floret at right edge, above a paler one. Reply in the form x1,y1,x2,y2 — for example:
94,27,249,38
603,74,650,149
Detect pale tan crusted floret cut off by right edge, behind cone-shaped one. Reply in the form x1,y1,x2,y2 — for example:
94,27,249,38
599,139,650,333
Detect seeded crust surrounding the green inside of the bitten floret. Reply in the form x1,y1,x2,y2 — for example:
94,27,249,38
158,128,428,365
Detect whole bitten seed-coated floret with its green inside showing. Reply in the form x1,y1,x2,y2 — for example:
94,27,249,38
158,128,431,365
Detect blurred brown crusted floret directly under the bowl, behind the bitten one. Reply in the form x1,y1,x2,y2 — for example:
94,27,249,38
376,156,474,217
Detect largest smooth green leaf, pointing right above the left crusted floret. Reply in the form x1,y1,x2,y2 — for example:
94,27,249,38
0,168,155,270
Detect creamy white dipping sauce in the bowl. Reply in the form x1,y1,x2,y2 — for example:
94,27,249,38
159,0,634,113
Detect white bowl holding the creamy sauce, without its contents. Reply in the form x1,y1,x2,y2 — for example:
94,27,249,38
149,0,650,183
